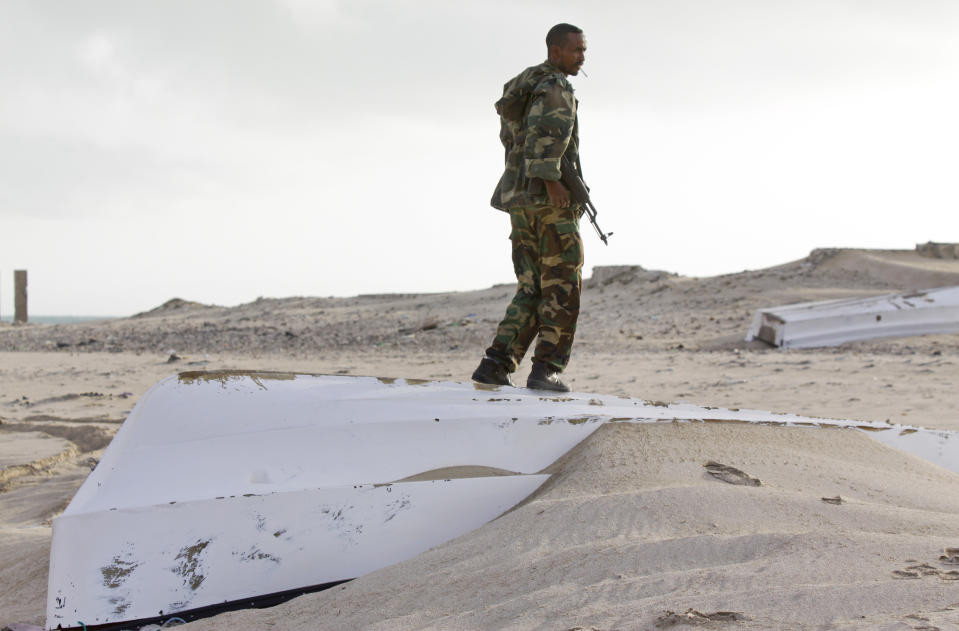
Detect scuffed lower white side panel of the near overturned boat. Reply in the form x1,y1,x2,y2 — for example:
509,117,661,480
47,475,549,628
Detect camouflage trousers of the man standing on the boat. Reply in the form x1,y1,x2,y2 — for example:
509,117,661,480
486,206,583,372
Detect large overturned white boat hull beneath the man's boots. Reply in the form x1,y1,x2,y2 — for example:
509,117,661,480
47,372,957,629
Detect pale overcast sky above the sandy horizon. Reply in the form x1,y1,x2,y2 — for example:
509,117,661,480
0,0,959,315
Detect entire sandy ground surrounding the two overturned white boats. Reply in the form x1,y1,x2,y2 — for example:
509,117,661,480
0,249,959,631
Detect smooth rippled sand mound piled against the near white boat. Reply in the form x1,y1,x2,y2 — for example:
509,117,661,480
192,423,959,630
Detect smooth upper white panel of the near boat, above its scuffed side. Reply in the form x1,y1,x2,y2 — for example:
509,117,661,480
64,373,601,515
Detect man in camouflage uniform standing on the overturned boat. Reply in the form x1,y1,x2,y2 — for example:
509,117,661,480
473,24,586,392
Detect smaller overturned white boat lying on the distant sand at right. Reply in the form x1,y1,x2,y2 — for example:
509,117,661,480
746,287,959,348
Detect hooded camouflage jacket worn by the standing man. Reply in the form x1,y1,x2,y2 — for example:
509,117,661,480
490,61,579,211
